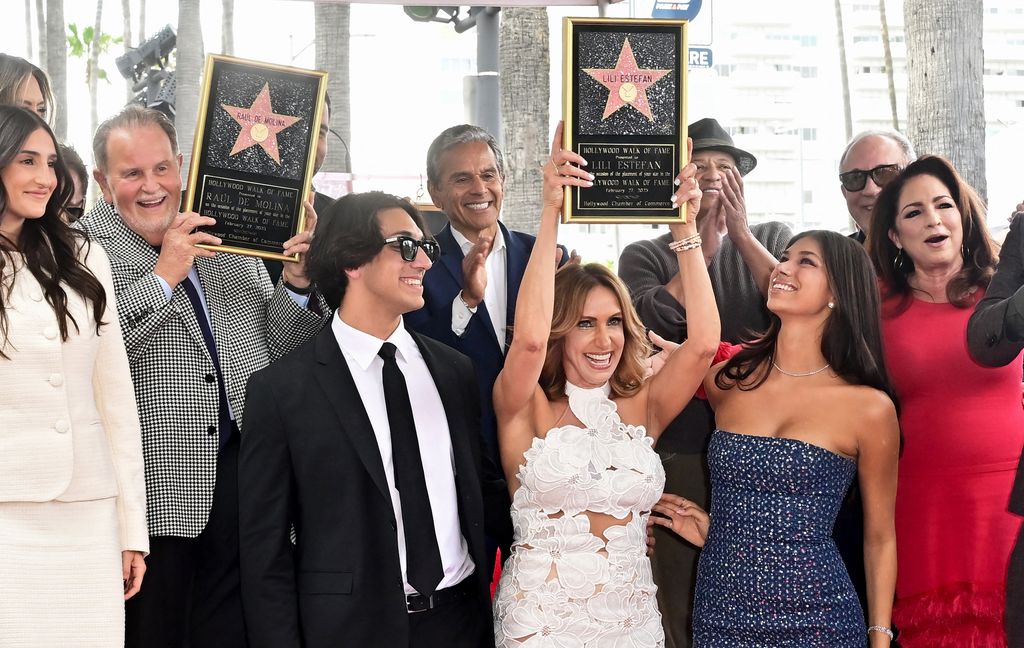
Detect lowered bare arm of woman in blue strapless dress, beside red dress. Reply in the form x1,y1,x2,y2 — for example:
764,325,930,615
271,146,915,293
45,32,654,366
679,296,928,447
857,392,899,648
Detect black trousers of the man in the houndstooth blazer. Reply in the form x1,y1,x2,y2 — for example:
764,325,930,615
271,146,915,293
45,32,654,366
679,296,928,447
125,432,248,648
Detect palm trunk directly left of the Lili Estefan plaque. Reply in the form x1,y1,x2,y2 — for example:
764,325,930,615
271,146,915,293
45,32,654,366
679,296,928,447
498,7,551,232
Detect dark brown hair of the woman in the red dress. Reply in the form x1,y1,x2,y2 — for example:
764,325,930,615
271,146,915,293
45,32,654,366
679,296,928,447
867,156,998,316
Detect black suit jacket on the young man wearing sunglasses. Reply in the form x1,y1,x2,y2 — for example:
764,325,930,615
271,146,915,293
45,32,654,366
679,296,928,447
239,328,499,648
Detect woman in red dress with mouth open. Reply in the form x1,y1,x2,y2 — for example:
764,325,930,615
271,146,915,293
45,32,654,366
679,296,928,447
868,156,1024,648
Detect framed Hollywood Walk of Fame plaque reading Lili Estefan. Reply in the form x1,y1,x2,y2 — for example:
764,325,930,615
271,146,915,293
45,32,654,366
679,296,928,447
562,17,686,223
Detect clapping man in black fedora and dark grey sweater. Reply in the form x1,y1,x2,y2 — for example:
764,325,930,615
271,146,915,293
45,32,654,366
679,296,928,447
618,119,793,648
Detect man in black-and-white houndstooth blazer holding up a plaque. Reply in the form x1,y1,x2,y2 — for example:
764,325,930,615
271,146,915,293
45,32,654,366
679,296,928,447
79,106,328,648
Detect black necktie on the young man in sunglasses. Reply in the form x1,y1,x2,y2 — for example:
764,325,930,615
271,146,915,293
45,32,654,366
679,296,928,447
378,342,444,596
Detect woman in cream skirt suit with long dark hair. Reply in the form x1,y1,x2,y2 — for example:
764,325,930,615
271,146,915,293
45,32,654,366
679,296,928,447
0,105,148,648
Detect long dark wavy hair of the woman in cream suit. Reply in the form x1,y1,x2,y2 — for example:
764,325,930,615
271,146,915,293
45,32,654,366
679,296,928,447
0,105,106,358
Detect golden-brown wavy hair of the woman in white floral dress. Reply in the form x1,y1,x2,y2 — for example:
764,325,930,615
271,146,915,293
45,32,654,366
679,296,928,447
540,263,650,400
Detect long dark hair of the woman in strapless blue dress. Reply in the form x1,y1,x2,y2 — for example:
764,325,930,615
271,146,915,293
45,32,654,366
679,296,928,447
715,229,896,403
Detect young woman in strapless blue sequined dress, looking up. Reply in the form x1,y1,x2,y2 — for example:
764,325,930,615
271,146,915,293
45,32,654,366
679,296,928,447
654,231,899,648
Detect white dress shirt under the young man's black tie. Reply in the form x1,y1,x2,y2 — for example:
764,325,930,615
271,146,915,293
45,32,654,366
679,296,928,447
331,315,474,594
